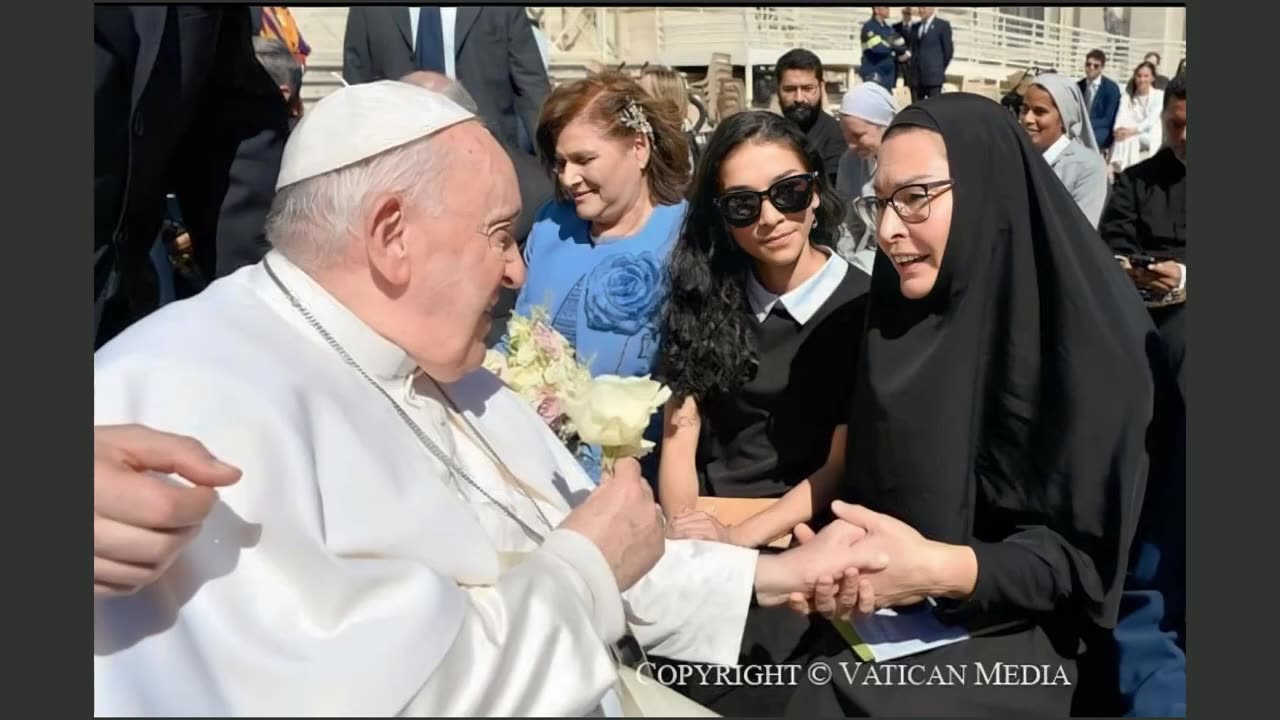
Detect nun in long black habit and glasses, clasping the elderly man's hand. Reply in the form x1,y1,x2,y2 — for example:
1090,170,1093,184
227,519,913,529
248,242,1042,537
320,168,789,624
787,92,1166,717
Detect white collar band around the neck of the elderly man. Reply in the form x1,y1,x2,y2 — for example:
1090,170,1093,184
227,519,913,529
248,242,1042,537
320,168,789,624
251,250,417,380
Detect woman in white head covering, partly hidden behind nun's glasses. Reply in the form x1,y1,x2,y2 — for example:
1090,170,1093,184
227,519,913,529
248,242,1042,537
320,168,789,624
836,82,897,275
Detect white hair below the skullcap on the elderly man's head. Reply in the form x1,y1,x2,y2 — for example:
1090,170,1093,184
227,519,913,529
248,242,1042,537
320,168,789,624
266,136,452,269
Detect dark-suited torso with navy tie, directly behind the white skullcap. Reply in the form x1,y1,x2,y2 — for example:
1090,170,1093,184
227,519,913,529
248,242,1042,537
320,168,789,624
342,5,550,151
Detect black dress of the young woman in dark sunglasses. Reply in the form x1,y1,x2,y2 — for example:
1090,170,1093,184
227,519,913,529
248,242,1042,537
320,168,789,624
650,256,870,716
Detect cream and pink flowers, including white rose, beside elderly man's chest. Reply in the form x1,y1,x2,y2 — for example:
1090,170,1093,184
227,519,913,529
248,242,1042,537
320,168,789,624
484,307,671,471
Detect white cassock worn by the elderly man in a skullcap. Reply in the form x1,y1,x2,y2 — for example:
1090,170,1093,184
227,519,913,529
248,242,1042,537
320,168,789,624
93,252,756,716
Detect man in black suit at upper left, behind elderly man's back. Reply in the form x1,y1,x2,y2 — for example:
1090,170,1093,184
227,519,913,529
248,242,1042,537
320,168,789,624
93,5,288,348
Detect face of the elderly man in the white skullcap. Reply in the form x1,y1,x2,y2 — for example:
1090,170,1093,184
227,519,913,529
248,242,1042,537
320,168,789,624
402,123,525,382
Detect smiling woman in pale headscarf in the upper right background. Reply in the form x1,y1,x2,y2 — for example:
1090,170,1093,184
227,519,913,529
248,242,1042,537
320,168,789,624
1021,73,1107,227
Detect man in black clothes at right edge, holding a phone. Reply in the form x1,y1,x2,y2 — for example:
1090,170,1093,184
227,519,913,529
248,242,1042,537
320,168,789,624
1100,76,1187,717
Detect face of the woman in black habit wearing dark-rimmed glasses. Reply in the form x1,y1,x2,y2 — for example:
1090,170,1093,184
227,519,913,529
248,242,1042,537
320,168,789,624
873,128,952,300
